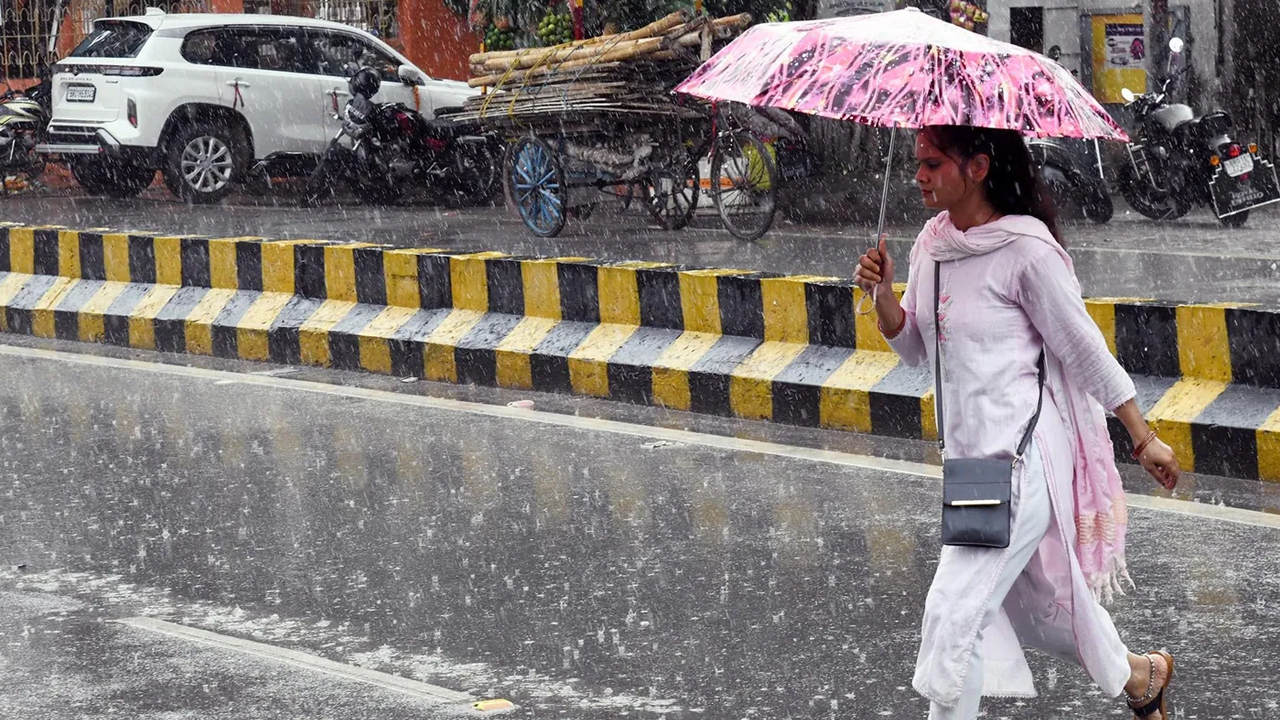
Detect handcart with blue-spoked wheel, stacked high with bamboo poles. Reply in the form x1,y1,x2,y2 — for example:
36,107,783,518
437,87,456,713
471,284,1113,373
467,13,777,240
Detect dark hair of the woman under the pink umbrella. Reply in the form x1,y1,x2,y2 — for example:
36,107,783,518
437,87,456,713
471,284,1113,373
920,126,1062,245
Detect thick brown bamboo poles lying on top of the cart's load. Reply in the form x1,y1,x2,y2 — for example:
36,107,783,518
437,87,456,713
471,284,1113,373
468,10,751,88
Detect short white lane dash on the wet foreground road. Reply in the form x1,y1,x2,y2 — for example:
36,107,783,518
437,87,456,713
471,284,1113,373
113,618,477,707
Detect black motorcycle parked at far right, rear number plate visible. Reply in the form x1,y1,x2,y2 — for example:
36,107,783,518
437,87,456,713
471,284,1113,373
1117,37,1280,228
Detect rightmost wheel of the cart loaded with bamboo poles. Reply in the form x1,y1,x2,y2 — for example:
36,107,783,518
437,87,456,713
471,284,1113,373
712,132,778,241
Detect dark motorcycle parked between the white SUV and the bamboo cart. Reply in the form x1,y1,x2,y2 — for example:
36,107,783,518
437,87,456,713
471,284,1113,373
307,68,502,205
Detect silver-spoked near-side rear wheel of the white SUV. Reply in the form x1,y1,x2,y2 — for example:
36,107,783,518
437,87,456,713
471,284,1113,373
164,122,246,204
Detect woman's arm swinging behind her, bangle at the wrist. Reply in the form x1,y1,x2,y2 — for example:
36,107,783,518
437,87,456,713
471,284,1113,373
1018,248,1180,488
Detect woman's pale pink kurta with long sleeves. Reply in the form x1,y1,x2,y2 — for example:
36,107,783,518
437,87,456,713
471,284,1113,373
890,215,1135,705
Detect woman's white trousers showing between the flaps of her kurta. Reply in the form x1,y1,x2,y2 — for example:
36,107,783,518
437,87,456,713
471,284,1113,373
929,443,1129,720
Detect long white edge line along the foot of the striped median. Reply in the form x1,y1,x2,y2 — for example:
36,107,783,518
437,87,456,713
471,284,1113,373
0,345,1280,529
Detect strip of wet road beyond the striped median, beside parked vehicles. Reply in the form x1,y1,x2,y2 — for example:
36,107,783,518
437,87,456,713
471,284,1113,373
0,190,1280,306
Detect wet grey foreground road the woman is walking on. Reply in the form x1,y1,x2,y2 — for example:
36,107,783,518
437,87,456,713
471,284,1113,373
0,346,1280,720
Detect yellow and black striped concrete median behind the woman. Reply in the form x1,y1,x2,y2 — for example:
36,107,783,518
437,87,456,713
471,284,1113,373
0,224,1280,480
